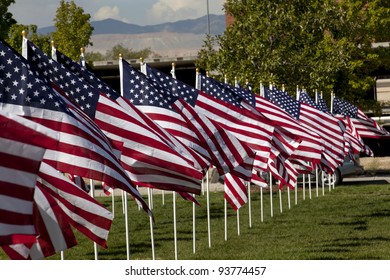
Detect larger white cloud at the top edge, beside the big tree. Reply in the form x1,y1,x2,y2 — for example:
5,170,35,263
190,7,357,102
148,0,224,22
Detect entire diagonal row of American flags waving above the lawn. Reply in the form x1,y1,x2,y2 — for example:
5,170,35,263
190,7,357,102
0,38,389,259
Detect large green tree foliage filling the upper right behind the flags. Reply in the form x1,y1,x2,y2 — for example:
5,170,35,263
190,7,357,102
197,0,390,110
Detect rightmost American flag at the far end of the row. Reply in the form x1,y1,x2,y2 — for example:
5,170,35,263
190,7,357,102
333,96,390,138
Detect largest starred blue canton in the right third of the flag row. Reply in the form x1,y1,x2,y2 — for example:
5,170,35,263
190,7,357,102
264,88,300,120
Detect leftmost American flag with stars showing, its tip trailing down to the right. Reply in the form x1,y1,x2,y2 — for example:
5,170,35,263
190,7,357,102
0,39,151,214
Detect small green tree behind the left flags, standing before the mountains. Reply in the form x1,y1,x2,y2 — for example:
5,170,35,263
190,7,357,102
53,0,93,60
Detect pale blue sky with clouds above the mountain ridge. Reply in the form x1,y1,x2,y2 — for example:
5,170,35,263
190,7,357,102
9,0,224,28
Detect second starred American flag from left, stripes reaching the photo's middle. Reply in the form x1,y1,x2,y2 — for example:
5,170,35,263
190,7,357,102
24,39,202,197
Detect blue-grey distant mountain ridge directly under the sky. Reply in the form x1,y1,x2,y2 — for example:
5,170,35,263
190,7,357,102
38,15,226,35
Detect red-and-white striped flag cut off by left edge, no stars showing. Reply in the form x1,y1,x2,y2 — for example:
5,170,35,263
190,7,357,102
0,110,55,245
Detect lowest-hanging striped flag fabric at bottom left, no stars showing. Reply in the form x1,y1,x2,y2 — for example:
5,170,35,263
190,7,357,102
3,163,113,259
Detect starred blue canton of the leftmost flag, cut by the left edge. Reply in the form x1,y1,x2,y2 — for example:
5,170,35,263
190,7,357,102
0,40,71,114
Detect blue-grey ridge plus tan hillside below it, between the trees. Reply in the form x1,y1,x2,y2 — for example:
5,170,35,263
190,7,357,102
38,15,226,57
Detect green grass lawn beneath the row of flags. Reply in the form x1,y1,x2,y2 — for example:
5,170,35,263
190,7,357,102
0,183,390,260
